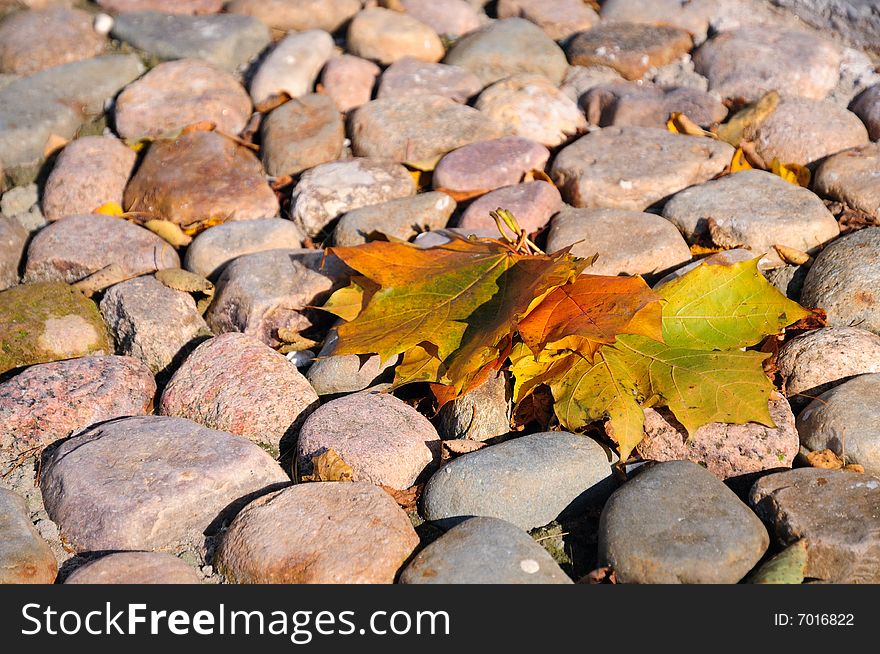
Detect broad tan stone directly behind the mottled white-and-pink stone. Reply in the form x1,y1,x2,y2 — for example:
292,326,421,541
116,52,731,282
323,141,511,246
349,95,504,169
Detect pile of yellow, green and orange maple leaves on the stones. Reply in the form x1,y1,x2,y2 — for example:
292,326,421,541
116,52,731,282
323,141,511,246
323,210,809,460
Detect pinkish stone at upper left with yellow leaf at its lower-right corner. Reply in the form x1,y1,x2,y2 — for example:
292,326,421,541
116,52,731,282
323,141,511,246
42,136,137,221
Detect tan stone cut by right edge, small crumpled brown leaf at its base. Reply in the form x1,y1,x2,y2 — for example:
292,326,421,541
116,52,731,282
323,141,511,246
797,374,880,477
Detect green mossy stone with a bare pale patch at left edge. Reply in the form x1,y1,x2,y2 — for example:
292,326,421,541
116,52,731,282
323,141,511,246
0,282,113,373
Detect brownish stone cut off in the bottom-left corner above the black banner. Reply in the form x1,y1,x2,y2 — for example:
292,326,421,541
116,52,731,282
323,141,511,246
0,488,58,584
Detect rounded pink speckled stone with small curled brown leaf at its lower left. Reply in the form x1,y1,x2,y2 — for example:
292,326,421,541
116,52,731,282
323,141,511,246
297,393,440,490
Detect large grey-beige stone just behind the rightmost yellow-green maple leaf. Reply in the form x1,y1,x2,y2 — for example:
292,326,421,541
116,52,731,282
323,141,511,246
663,170,840,256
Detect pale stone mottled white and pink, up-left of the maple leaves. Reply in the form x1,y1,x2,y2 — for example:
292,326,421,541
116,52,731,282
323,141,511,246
290,158,416,236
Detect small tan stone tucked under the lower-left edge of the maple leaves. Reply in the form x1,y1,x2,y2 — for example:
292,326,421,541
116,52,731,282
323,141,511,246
439,373,512,441
